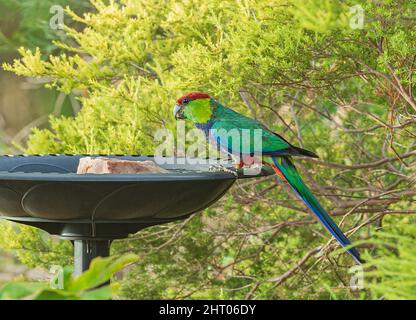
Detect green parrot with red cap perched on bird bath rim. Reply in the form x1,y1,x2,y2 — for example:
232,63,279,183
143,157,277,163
173,92,362,264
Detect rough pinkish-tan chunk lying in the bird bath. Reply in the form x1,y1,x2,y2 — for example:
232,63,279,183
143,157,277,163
77,157,168,174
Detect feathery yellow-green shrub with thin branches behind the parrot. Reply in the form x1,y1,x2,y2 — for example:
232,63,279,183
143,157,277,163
0,0,416,299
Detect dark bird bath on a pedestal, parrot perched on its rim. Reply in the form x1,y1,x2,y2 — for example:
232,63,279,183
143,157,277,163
0,155,271,274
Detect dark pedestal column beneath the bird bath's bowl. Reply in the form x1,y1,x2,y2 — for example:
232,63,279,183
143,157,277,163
73,240,111,275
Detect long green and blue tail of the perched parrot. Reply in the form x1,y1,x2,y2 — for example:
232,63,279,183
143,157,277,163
271,157,362,264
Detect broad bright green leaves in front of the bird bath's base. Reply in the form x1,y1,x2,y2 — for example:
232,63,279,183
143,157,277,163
0,254,137,300
